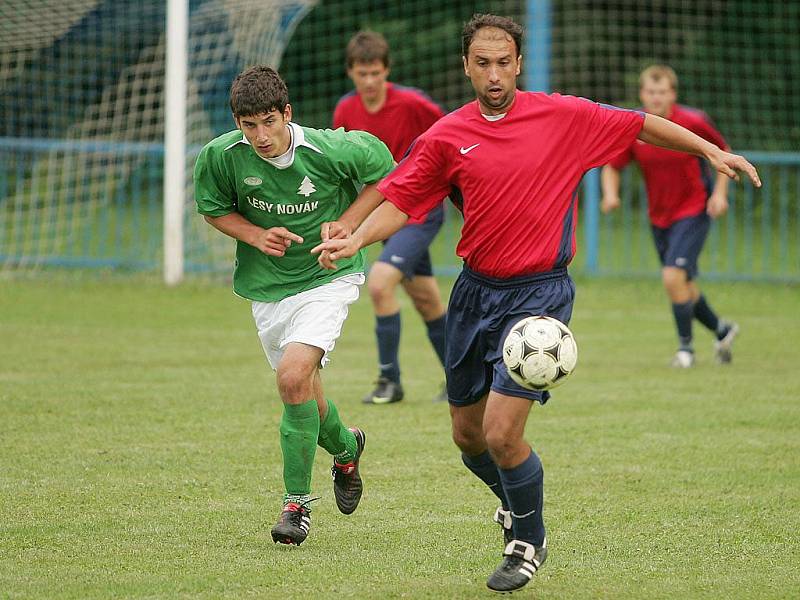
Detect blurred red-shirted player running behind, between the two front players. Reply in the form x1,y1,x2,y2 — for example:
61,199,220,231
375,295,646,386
333,31,447,404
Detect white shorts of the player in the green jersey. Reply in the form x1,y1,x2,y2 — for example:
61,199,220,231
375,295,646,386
253,273,364,370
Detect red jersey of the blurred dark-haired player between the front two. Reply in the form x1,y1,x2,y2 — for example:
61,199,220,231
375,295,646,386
333,82,444,224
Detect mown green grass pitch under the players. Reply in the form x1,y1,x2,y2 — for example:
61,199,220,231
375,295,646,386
0,278,800,599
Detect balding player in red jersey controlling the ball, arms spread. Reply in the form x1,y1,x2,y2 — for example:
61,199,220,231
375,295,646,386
312,15,760,592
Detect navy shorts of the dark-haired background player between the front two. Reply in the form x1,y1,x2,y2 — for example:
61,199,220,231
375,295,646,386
378,204,444,279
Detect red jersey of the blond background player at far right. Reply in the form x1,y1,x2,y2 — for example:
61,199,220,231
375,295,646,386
609,105,728,228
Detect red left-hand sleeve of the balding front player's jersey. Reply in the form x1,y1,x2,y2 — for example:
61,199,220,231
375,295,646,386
378,135,450,219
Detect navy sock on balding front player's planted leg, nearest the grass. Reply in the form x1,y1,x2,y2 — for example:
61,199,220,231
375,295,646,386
499,450,545,547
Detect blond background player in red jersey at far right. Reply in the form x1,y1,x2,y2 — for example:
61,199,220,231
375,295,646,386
600,65,739,368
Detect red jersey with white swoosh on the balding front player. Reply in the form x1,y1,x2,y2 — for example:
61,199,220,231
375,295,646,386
378,90,644,278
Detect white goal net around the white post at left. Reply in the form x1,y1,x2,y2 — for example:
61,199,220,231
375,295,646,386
0,0,314,270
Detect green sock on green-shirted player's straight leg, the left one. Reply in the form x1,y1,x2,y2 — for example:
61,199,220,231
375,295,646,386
280,400,319,495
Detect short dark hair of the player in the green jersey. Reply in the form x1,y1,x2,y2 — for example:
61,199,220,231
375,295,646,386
230,65,289,117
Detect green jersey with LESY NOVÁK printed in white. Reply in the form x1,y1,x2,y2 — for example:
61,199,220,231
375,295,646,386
194,123,394,302
